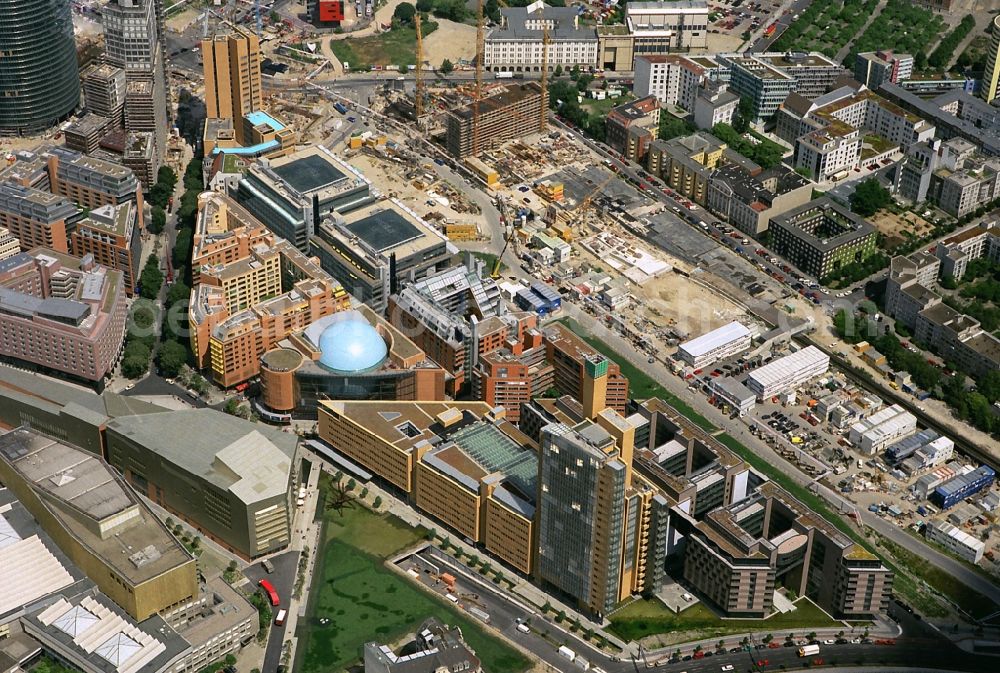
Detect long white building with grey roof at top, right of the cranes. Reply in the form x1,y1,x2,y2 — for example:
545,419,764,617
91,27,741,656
483,1,597,72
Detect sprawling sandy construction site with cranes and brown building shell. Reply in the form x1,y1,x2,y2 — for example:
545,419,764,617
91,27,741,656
191,0,746,362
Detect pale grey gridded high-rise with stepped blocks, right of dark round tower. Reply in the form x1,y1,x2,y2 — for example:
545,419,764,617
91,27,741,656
101,0,169,165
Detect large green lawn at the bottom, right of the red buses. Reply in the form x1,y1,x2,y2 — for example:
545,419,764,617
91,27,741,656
295,480,530,673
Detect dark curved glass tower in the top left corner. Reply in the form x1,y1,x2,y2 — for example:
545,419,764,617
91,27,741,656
0,0,80,135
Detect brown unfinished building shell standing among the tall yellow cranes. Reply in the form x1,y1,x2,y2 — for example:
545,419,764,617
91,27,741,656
447,82,548,159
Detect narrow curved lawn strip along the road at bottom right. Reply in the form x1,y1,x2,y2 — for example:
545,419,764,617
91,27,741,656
610,598,842,640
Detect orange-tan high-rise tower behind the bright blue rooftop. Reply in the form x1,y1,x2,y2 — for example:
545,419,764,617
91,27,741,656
201,28,264,143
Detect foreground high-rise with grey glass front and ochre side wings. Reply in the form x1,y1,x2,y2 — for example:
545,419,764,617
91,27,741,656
536,409,669,616
